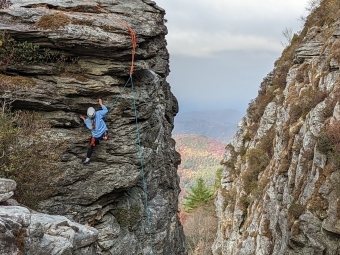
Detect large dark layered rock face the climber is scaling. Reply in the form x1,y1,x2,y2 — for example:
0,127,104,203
0,0,186,254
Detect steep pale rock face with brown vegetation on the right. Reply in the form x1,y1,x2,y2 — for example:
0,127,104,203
212,1,340,255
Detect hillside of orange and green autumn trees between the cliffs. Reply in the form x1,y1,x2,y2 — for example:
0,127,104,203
173,134,225,202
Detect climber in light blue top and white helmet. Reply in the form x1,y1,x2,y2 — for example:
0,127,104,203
79,99,108,164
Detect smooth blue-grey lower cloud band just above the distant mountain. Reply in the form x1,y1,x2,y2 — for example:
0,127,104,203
168,51,276,112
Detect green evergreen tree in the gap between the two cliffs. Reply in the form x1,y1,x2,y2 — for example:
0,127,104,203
183,177,214,212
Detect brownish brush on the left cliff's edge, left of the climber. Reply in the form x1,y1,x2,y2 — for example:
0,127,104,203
0,75,64,208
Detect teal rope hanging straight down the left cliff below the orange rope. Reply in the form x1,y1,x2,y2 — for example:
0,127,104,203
130,74,154,254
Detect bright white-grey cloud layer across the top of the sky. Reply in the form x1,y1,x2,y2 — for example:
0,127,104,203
157,0,305,57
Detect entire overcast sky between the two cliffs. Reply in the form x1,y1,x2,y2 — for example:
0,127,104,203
155,0,308,113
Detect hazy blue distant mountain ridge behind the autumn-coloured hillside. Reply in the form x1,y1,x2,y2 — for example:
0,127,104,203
172,110,244,144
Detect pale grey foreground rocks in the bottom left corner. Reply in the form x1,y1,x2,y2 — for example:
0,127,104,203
0,179,99,255
